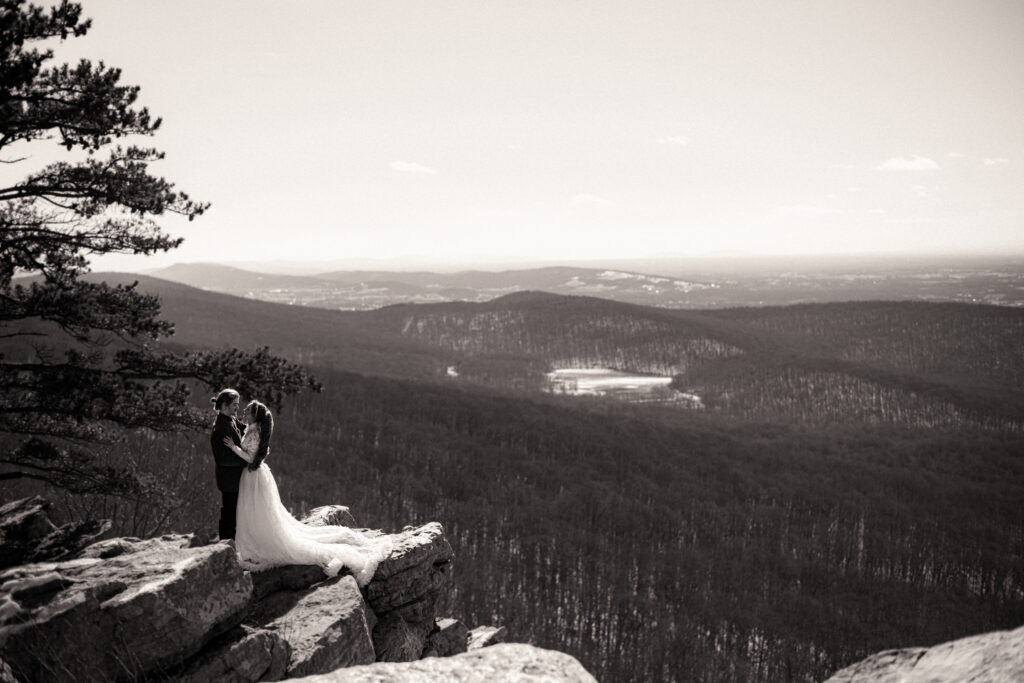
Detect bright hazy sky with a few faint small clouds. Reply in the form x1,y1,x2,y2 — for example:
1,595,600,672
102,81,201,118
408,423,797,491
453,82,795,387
9,0,1024,267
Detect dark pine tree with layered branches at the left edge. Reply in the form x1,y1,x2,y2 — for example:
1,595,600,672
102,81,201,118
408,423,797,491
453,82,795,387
0,0,319,496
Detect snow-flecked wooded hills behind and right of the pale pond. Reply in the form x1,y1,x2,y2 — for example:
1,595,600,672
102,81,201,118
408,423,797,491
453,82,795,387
367,293,1024,430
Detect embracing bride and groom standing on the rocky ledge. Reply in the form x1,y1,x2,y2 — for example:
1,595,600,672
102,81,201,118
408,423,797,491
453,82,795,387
210,389,391,586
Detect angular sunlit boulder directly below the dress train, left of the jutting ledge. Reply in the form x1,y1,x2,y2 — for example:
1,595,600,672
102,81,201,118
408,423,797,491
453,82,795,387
246,567,376,678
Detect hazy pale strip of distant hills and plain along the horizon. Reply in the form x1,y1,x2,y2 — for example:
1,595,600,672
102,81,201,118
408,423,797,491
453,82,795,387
148,261,1024,310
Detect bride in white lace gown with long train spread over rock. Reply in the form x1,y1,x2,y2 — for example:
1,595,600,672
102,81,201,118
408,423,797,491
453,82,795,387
224,400,392,586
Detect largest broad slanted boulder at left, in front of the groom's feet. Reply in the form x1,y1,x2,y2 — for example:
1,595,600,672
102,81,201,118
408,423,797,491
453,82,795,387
0,543,252,680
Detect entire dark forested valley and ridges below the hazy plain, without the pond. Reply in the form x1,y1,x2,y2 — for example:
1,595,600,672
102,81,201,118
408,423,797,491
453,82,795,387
9,274,1024,681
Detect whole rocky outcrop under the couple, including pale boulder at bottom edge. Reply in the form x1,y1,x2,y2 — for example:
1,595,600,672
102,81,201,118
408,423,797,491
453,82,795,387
0,499,569,683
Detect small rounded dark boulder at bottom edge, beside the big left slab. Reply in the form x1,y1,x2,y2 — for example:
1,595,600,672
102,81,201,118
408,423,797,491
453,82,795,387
170,626,292,683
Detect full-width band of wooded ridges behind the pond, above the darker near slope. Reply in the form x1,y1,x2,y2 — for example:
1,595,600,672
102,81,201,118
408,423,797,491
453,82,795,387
77,273,1024,429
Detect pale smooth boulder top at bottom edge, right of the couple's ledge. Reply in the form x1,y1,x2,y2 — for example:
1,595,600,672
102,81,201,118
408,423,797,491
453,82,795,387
288,643,597,683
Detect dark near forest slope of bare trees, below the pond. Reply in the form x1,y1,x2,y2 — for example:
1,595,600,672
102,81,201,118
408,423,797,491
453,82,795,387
68,371,1024,682
